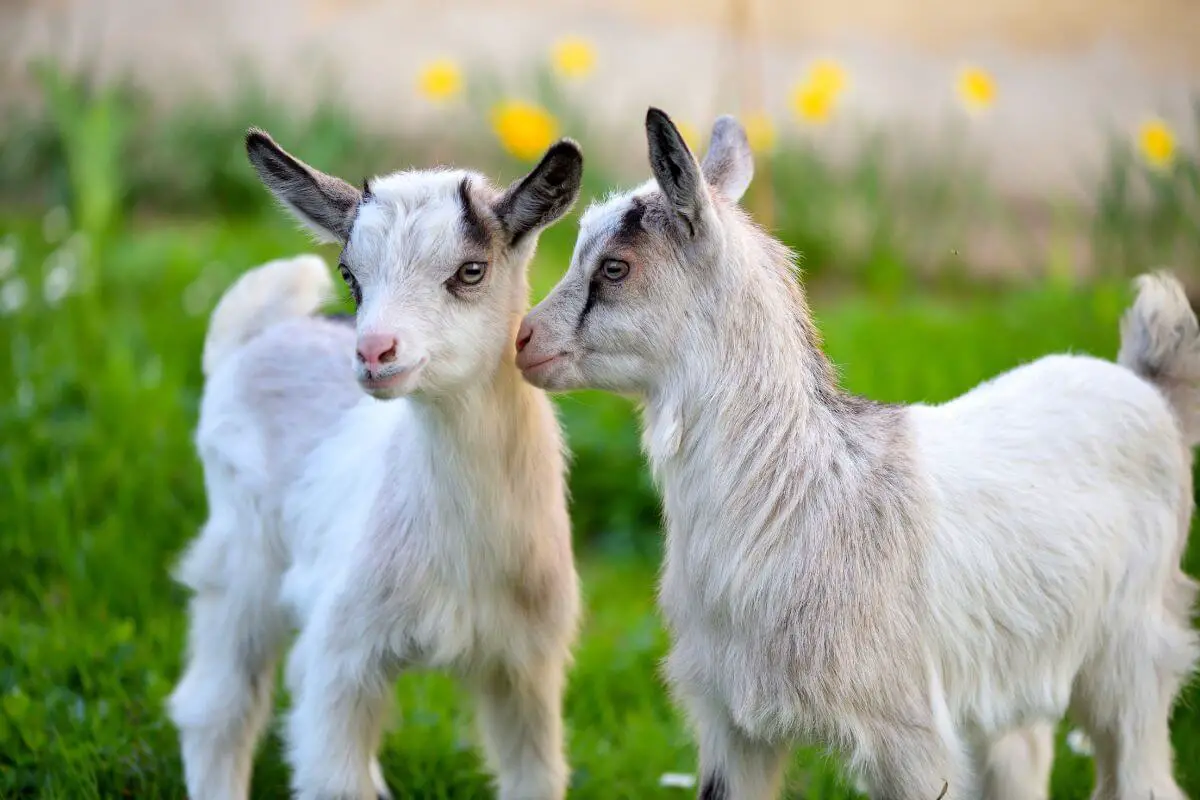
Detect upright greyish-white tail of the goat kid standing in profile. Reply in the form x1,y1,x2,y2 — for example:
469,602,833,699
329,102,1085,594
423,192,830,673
1117,272,1200,446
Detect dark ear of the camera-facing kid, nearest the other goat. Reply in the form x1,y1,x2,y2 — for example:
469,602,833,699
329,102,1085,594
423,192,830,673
493,139,583,245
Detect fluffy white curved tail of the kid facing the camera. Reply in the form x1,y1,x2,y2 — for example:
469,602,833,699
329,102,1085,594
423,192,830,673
202,253,334,375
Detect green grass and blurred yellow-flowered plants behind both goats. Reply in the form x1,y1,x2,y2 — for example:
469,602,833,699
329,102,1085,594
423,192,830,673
0,1,1200,799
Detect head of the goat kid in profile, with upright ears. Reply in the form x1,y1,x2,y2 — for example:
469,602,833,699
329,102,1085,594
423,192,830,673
517,108,754,395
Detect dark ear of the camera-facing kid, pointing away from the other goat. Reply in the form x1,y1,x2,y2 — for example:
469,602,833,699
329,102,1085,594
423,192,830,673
246,128,362,245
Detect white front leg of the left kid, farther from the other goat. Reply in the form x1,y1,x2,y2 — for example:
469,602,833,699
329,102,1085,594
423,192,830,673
287,587,395,800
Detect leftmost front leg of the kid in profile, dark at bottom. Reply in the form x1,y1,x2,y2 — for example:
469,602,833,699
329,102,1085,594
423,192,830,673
689,699,791,800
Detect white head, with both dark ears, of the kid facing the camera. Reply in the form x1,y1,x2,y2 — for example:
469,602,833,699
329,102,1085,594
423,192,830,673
246,130,583,399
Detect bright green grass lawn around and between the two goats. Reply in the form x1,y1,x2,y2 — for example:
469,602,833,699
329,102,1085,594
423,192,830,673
0,208,1200,799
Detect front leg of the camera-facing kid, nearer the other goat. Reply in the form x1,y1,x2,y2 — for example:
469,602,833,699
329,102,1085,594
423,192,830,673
478,651,568,800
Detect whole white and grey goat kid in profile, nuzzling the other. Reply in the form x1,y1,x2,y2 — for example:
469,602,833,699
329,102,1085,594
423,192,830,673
517,109,1200,800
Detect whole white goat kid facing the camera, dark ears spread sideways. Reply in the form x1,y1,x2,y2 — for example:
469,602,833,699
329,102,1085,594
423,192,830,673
170,131,582,800
